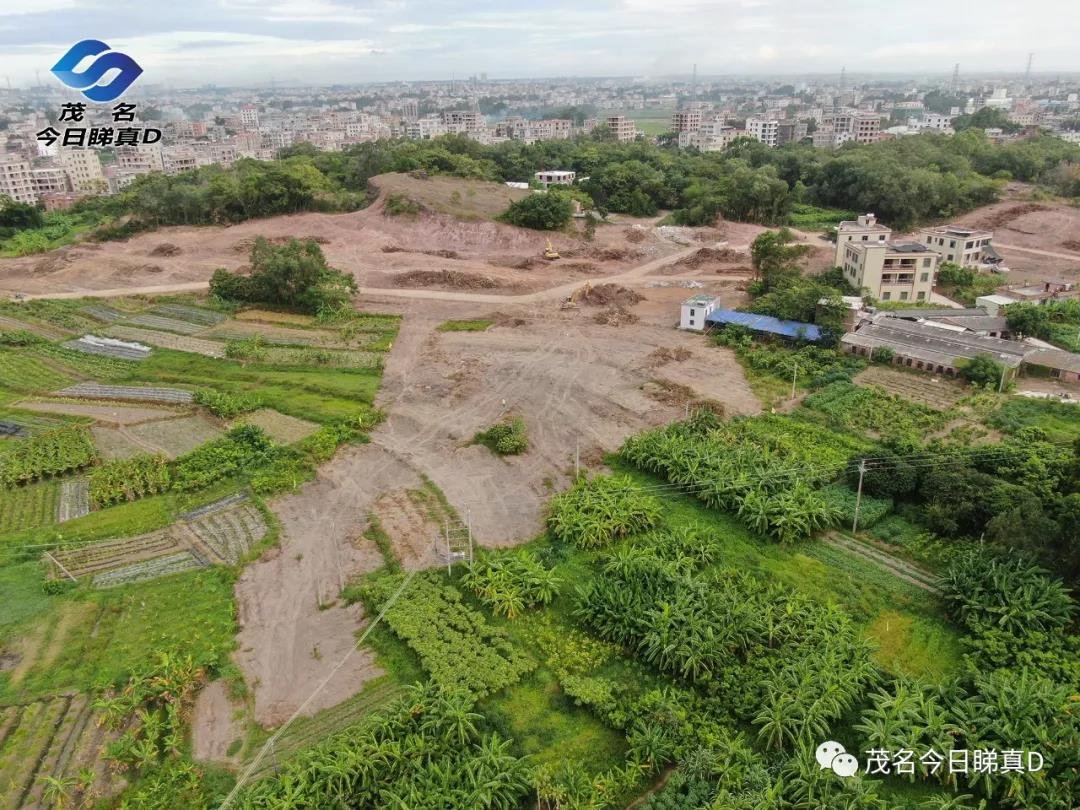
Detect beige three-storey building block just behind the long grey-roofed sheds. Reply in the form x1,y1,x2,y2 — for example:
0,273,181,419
840,241,941,301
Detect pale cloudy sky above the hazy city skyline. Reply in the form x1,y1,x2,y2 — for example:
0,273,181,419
0,0,1080,86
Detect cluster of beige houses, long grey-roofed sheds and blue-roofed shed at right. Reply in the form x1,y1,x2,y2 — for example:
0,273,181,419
679,214,1080,382
